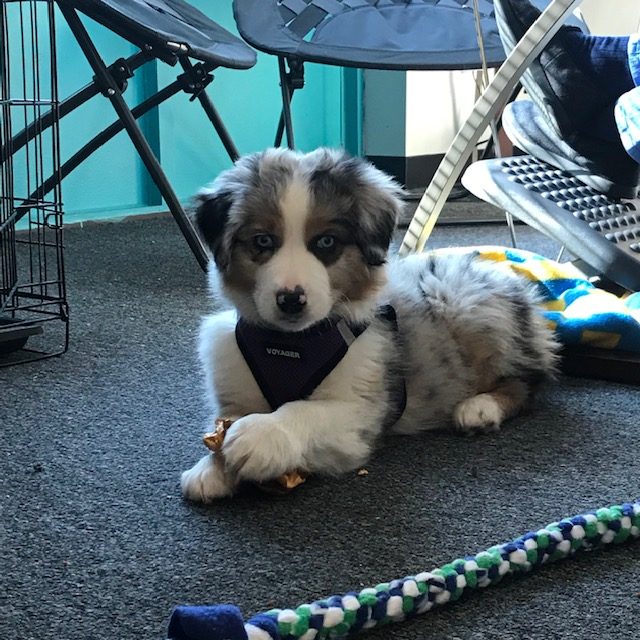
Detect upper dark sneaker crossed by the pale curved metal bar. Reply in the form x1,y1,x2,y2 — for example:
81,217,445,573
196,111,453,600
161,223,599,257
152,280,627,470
494,0,599,137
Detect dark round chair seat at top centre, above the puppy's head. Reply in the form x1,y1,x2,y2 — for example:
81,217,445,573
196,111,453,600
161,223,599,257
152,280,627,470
233,0,505,70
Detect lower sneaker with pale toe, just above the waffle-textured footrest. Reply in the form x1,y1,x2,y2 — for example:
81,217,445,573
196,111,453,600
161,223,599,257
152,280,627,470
502,100,640,200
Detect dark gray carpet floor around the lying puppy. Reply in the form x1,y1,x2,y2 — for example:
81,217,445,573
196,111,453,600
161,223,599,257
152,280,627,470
0,209,640,640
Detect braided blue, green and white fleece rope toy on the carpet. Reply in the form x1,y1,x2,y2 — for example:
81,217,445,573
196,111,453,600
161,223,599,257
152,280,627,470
168,501,640,640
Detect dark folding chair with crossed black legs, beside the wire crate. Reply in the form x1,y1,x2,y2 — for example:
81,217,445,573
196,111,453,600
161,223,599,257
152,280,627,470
0,0,256,269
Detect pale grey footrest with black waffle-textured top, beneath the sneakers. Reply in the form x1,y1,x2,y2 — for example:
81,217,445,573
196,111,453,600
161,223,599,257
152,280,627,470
462,156,640,291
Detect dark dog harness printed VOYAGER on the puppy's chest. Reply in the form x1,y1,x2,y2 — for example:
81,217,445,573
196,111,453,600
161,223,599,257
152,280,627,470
236,305,406,417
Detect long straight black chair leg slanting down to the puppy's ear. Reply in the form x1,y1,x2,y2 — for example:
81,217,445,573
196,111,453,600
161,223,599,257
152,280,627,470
58,0,209,271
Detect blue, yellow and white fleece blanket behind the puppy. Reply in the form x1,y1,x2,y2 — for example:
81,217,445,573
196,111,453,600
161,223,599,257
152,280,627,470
452,247,640,352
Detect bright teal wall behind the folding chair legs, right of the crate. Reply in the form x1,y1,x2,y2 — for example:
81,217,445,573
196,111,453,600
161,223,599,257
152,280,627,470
45,0,350,223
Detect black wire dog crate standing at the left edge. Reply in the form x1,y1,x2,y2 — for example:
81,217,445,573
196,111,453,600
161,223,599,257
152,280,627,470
0,0,69,366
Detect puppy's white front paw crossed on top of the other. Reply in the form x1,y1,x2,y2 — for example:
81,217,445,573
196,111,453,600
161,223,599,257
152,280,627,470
222,413,302,482
